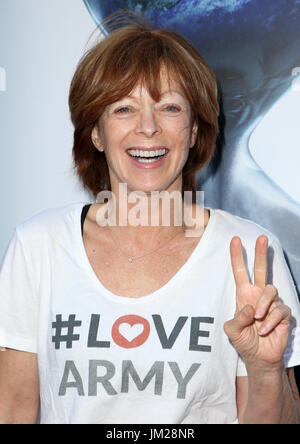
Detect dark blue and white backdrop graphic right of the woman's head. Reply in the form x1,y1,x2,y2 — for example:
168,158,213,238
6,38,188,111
84,0,300,302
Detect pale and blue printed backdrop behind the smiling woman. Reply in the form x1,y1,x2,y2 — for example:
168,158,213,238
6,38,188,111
0,0,300,302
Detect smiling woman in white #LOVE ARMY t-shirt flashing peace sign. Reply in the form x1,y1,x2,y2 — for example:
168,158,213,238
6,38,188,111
0,17,300,424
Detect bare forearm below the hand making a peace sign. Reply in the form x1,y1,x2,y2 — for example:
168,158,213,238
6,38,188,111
241,368,300,424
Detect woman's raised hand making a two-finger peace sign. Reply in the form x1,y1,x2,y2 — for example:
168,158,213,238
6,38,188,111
224,235,291,368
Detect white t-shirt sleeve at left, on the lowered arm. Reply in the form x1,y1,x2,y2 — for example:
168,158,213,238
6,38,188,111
0,228,38,353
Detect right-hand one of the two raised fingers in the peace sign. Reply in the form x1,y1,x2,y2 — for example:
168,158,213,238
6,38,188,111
254,235,269,288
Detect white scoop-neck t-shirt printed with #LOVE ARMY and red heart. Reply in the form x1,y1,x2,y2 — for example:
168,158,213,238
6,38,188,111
0,202,300,424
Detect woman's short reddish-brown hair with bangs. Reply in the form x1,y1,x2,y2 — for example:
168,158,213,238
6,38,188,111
69,14,219,197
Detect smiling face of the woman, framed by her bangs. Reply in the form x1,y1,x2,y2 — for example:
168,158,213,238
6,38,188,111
92,75,197,192
